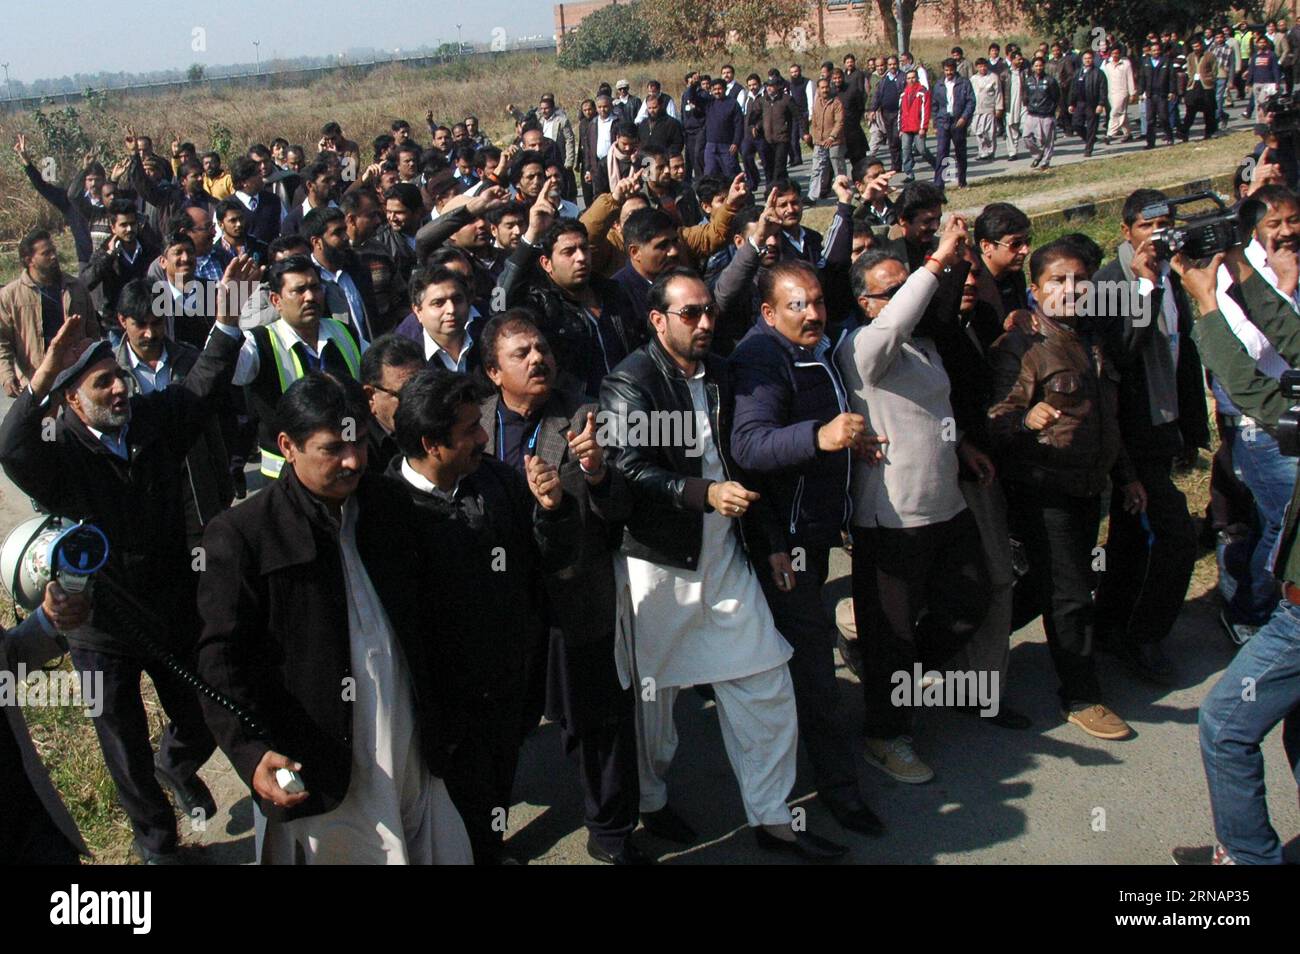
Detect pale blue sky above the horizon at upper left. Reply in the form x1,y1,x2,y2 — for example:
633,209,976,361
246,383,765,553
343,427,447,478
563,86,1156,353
0,0,555,83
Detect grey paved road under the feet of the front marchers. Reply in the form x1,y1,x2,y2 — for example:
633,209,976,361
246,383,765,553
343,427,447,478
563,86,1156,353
0,402,1300,864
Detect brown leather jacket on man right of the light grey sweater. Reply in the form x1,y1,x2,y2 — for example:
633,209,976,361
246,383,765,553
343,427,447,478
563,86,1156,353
988,313,1135,496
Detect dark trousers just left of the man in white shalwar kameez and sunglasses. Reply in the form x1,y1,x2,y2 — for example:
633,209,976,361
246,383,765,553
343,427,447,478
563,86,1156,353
546,629,641,855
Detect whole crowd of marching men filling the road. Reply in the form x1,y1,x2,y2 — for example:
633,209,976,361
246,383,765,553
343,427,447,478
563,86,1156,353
0,21,1300,863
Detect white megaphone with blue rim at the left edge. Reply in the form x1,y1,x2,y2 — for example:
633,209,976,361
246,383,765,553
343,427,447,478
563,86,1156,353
0,513,108,612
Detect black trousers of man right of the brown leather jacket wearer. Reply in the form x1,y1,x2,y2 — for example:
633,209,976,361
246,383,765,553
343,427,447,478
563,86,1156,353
1096,458,1196,643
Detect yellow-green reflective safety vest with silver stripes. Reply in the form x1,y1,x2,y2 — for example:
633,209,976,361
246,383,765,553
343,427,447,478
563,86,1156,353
246,318,361,480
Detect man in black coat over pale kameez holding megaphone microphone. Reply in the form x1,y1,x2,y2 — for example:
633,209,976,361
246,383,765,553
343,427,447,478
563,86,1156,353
198,372,472,864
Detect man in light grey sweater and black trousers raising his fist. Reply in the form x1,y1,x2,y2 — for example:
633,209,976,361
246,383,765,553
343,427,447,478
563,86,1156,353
835,217,1000,785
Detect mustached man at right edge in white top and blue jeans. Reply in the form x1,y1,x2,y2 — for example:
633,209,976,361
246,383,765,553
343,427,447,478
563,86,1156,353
1201,184,1300,645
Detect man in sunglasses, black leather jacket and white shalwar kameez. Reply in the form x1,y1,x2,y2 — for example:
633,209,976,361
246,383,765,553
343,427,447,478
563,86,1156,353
601,269,845,860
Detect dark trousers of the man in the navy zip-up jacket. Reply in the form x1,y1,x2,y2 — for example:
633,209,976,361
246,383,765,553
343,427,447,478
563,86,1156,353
758,547,858,803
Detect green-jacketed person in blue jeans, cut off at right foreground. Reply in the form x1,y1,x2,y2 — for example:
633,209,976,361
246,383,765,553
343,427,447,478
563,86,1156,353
1173,247,1300,864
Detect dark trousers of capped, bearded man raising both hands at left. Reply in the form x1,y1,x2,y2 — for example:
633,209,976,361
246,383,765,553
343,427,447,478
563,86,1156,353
72,646,217,854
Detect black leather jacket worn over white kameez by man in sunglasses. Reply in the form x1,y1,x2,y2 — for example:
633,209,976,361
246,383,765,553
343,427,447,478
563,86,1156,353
598,338,784,572
